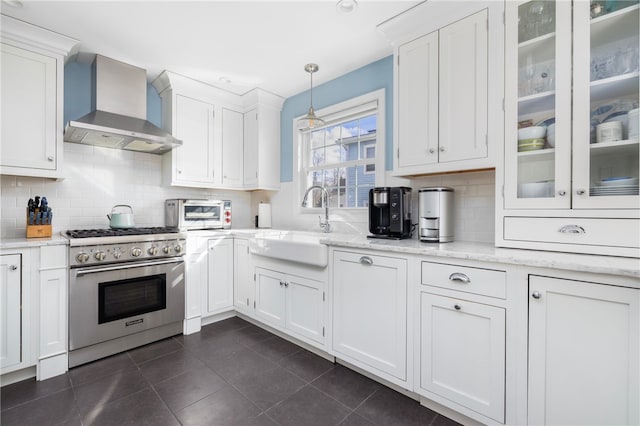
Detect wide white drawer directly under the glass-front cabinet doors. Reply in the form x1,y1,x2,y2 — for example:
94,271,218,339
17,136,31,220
504,217,640,248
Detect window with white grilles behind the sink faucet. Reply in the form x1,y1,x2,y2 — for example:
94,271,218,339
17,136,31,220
300,90,384,208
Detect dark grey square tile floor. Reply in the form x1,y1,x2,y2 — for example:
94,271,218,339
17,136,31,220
0,317,456,426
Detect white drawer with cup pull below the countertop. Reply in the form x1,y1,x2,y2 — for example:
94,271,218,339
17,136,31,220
421,262,507,299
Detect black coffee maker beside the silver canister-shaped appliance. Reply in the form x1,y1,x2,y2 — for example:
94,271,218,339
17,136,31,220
368,186,411,240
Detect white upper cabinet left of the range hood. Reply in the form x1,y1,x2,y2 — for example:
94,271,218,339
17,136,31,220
0,15,77,178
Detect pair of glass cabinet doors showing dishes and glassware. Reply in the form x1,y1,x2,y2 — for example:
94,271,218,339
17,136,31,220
504,0,640,209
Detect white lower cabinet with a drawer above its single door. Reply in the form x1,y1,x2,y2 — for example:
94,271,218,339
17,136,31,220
415,262,507,423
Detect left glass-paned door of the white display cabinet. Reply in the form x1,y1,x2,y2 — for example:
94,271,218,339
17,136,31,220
504,0,571,209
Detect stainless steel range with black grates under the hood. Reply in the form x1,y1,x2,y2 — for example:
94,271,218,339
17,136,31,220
63,228,186,367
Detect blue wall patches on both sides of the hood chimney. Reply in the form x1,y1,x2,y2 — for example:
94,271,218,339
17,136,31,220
64,61,162,127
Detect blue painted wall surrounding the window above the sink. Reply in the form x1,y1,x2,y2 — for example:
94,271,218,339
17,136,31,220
280,56,393,182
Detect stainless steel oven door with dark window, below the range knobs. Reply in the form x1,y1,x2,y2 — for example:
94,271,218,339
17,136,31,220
69,257,185,350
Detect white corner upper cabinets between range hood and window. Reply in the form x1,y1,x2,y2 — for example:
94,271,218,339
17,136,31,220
153,71,284,189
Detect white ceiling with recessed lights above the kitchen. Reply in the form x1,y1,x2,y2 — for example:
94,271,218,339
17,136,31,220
1,0,421,98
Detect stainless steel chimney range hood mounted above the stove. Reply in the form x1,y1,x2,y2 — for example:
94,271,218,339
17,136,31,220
64,55,182,154
